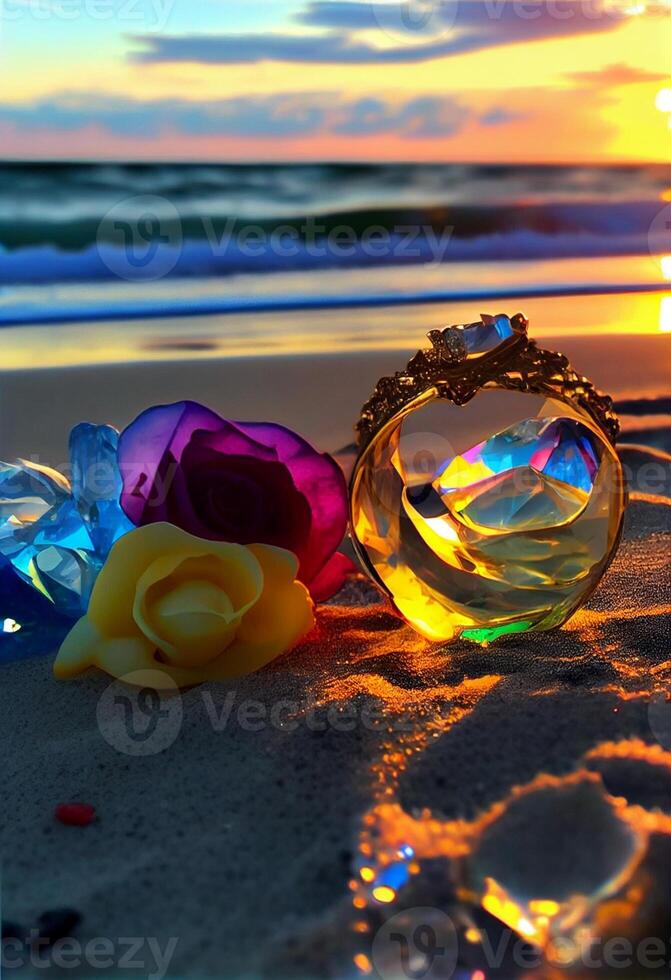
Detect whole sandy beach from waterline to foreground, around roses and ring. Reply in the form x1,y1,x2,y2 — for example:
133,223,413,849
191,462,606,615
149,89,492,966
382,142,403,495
0,276,671,980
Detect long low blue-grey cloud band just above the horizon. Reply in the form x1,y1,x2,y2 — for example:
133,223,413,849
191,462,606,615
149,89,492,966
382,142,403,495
0,93,506,139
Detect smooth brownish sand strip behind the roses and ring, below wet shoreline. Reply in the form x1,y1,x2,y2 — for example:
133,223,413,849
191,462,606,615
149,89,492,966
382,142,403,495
0,330,671,468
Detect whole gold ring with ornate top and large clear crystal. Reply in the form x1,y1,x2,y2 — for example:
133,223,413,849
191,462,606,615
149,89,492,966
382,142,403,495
350,313,626,643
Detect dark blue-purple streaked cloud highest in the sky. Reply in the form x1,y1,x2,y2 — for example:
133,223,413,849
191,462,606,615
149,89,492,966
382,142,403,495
131,0,625,65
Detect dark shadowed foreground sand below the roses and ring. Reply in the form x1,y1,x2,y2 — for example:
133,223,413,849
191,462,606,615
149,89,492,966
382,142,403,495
0,456,671,978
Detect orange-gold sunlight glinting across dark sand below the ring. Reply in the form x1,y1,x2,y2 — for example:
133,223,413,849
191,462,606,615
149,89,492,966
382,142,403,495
297,512,671,976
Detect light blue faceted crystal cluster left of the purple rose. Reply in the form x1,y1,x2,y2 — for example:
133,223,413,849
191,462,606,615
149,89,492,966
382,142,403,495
0,422,133,617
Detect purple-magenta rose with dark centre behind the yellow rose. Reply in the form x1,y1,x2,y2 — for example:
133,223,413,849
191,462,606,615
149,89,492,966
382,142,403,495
119,401,352,600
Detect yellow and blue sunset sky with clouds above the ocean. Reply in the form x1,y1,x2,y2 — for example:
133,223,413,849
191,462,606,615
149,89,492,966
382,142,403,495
0,0,671,162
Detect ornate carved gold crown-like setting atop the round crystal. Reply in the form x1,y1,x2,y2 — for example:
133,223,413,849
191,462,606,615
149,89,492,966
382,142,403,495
356,313,620,450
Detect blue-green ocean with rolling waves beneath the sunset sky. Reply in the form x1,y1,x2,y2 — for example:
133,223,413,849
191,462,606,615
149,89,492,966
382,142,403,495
0,163,671,287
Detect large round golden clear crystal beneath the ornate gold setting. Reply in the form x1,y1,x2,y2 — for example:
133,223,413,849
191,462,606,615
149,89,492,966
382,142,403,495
352,388,625,642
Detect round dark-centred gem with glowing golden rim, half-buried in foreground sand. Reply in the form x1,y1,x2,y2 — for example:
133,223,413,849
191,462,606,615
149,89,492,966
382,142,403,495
458,770,648,944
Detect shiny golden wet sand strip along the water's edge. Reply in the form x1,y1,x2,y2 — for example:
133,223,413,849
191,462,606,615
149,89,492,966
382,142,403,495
0,278,671,372
